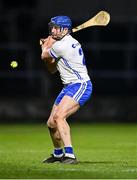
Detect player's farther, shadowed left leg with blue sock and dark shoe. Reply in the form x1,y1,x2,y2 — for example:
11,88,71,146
43,105,63,163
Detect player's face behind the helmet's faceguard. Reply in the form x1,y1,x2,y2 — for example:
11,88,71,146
51,26,68,40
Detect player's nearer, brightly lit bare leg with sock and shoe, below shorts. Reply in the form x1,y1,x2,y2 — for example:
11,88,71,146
53,96,80,164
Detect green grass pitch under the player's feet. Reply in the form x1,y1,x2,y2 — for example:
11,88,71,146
0,124,137,179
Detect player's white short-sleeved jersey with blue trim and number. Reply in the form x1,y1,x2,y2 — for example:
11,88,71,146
49,35,90,84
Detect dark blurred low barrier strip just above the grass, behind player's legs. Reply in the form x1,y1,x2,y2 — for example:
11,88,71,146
0,96,137,123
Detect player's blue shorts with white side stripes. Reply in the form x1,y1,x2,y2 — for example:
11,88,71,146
55,80,92,106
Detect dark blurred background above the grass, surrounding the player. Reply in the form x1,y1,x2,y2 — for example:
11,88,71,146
0,0,137,122
